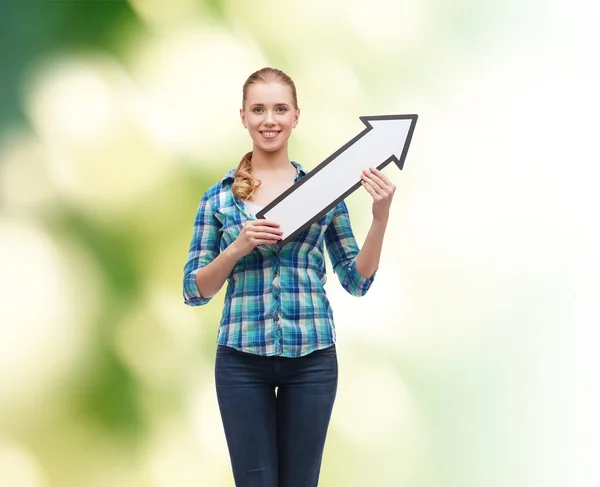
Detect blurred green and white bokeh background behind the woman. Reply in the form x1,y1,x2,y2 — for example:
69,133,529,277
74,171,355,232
0,0,600,487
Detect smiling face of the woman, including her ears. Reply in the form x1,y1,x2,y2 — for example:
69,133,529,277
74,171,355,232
240,81,300,152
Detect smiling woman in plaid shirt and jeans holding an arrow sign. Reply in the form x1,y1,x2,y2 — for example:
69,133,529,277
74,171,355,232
184,68,395,487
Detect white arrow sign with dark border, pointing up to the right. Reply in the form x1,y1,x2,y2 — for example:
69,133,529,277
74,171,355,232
256,115,417,246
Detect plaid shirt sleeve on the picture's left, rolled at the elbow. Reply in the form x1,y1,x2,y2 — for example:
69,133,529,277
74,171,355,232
183,194,221,306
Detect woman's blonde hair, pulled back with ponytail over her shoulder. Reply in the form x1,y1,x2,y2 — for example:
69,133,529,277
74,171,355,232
231,68,298,200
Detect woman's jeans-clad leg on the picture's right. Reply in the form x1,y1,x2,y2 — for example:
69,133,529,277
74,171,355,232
277,346,338,487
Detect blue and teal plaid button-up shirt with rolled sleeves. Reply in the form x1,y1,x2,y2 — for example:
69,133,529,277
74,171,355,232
183,162,375,357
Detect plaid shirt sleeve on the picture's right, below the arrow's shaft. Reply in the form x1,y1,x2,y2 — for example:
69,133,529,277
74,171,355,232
325,201,376,296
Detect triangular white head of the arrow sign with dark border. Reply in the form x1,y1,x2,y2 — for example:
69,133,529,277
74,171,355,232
360,115,418,169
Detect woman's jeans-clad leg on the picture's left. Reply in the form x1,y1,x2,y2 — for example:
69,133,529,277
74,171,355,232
215,346,278,487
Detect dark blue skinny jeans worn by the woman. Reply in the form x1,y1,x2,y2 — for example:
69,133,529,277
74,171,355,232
215,345,338,487
